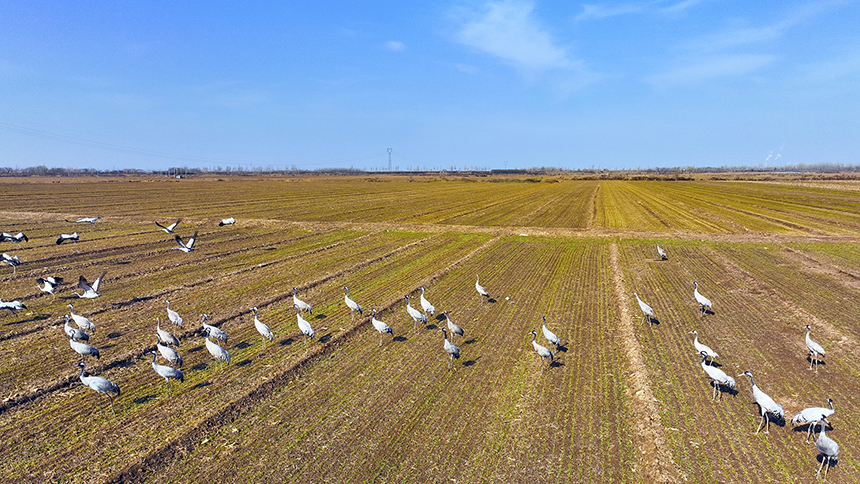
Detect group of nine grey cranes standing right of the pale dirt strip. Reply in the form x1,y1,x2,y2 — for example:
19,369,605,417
644,244,839,480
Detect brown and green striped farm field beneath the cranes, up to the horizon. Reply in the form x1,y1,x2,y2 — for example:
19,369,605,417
0,176,860,483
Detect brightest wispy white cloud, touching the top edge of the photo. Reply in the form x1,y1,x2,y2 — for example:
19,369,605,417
457,0,572,71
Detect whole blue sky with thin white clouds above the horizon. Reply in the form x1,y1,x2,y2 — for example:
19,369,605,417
0,0,860,170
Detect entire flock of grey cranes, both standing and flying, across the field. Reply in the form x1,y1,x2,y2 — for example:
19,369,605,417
0,225,839,479
